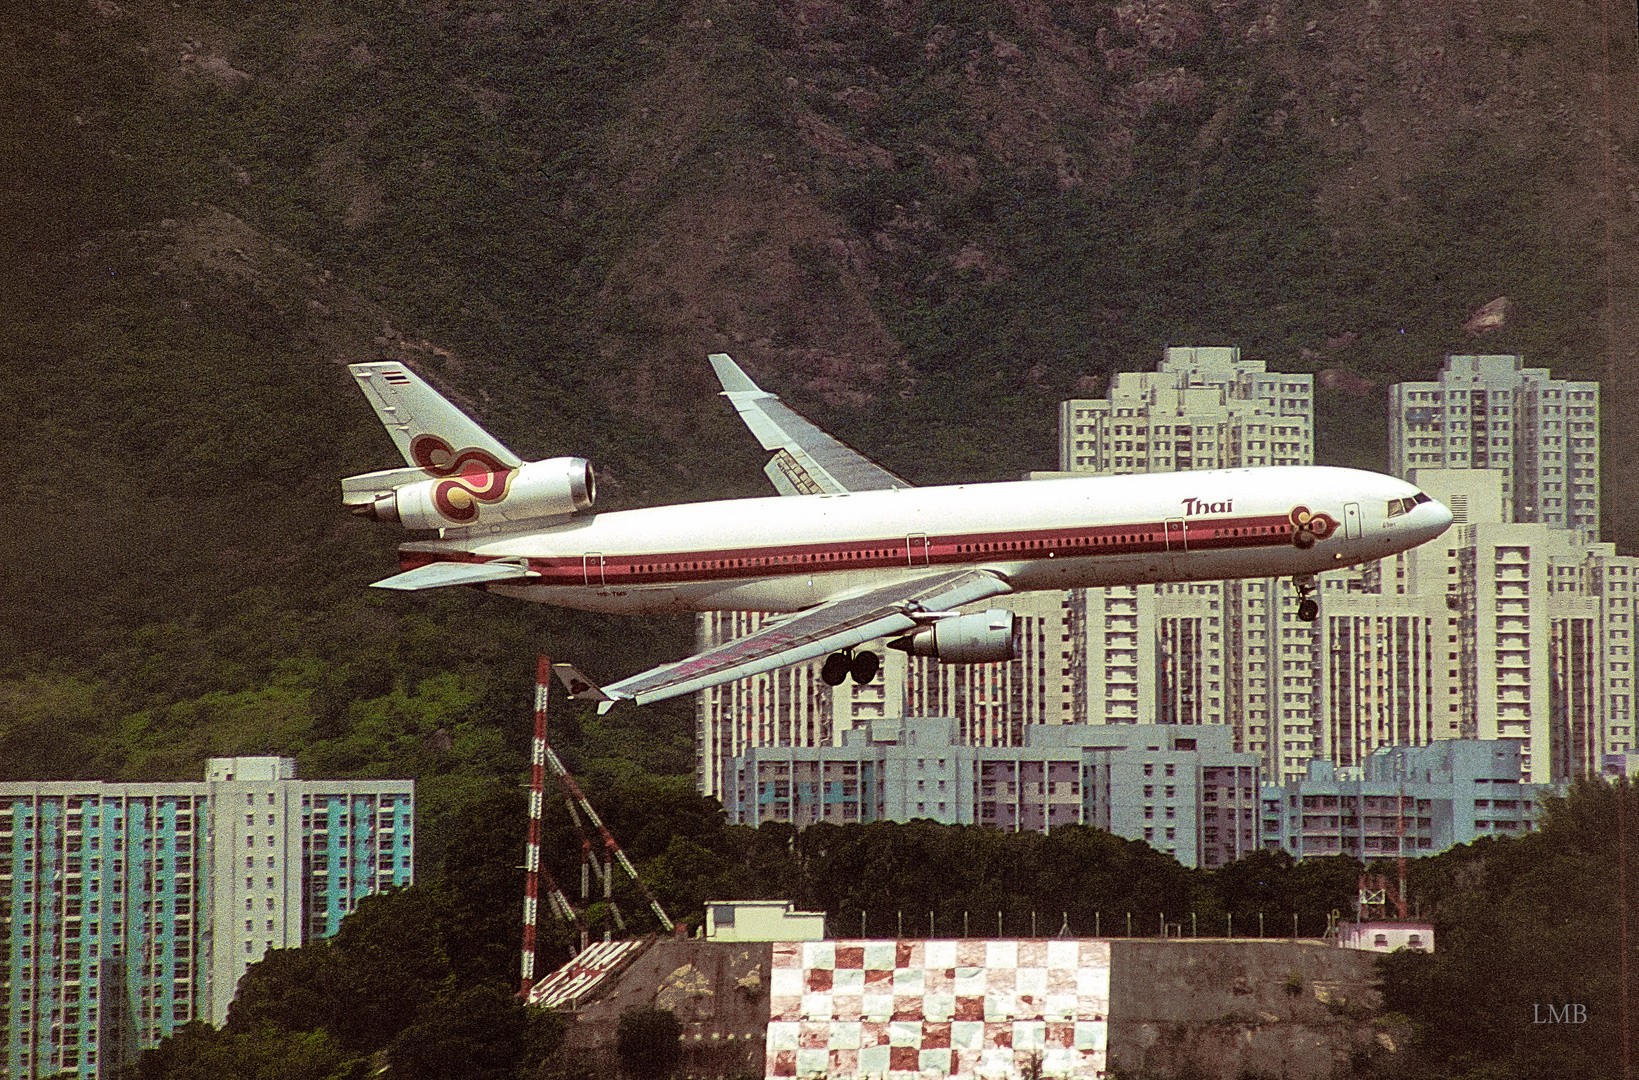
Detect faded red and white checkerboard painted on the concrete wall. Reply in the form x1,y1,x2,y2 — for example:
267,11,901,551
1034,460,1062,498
765,939,1110,1080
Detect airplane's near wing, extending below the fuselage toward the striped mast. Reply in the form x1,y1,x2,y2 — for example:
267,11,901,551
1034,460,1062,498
554,569,1013,711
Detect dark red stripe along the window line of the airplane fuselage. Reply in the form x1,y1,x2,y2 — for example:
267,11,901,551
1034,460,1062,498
398,515,1292,587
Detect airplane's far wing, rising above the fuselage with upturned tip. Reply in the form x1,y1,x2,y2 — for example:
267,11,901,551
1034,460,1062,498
710,352,913,495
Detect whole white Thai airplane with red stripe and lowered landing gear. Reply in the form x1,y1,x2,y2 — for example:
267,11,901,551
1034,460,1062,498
343,354,1451,710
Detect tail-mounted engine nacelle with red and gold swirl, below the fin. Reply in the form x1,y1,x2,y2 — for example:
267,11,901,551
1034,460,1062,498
354,457,598,529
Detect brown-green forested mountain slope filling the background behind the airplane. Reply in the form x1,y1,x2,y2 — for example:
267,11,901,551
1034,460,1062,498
0,0,1639,799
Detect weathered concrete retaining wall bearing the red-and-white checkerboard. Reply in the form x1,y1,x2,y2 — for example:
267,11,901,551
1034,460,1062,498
550,937,1395,1080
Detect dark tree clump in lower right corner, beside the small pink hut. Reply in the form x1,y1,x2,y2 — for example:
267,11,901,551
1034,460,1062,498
1377,780,1639,1080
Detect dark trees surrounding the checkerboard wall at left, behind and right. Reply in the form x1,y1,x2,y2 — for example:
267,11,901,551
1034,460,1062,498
108,783,1639,1080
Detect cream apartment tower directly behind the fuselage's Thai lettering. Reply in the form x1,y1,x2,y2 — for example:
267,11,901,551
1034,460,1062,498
1059,347,1326,778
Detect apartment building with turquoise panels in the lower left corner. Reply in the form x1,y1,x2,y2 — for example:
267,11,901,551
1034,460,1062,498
0,757,415,1078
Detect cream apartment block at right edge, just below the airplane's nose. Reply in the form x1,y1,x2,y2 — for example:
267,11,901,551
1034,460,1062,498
1314,469,1639,783
